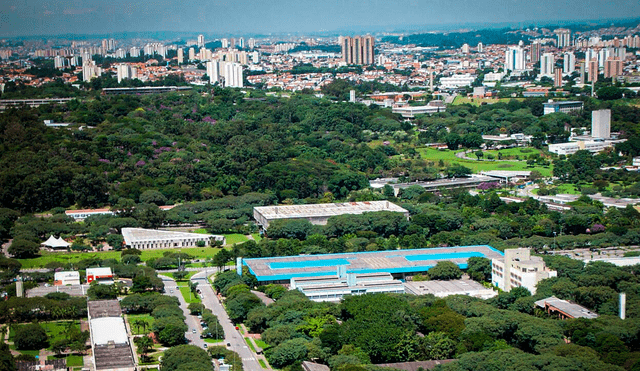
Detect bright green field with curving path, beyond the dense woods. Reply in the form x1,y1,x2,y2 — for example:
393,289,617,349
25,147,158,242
418,148,553,176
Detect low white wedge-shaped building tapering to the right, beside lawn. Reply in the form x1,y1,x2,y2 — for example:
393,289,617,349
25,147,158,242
122,228,225,250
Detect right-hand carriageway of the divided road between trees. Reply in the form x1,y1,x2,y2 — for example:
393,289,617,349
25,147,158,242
191,269,262,371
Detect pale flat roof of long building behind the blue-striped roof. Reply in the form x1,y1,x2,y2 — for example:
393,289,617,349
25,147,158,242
253,201,408,220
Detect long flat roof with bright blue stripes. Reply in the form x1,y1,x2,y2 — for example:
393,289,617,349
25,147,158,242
244,245,504,282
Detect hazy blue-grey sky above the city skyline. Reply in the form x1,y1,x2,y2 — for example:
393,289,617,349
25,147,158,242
0,0,640,36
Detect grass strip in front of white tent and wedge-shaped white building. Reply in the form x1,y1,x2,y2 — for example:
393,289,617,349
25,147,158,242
18,247,228,268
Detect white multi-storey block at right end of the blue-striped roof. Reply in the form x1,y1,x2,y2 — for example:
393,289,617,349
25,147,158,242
491,248,558,294
